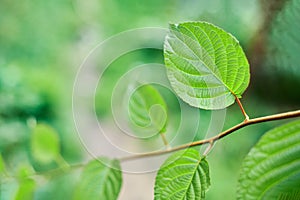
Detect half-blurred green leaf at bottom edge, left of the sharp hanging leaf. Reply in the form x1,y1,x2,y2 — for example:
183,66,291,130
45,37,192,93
74,158,122,200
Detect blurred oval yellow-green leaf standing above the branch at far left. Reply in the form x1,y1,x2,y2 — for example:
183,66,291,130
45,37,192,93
31,124,60,164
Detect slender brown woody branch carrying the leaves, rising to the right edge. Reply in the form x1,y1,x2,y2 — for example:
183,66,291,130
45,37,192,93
119,110,300,162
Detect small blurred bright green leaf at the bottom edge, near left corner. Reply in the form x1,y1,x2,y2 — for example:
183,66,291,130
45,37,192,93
15,178,36,200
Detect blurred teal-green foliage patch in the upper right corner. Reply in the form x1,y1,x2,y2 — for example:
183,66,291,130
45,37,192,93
266,0,300,76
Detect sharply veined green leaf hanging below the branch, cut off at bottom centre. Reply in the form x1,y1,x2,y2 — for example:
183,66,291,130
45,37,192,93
154,149,210,200
